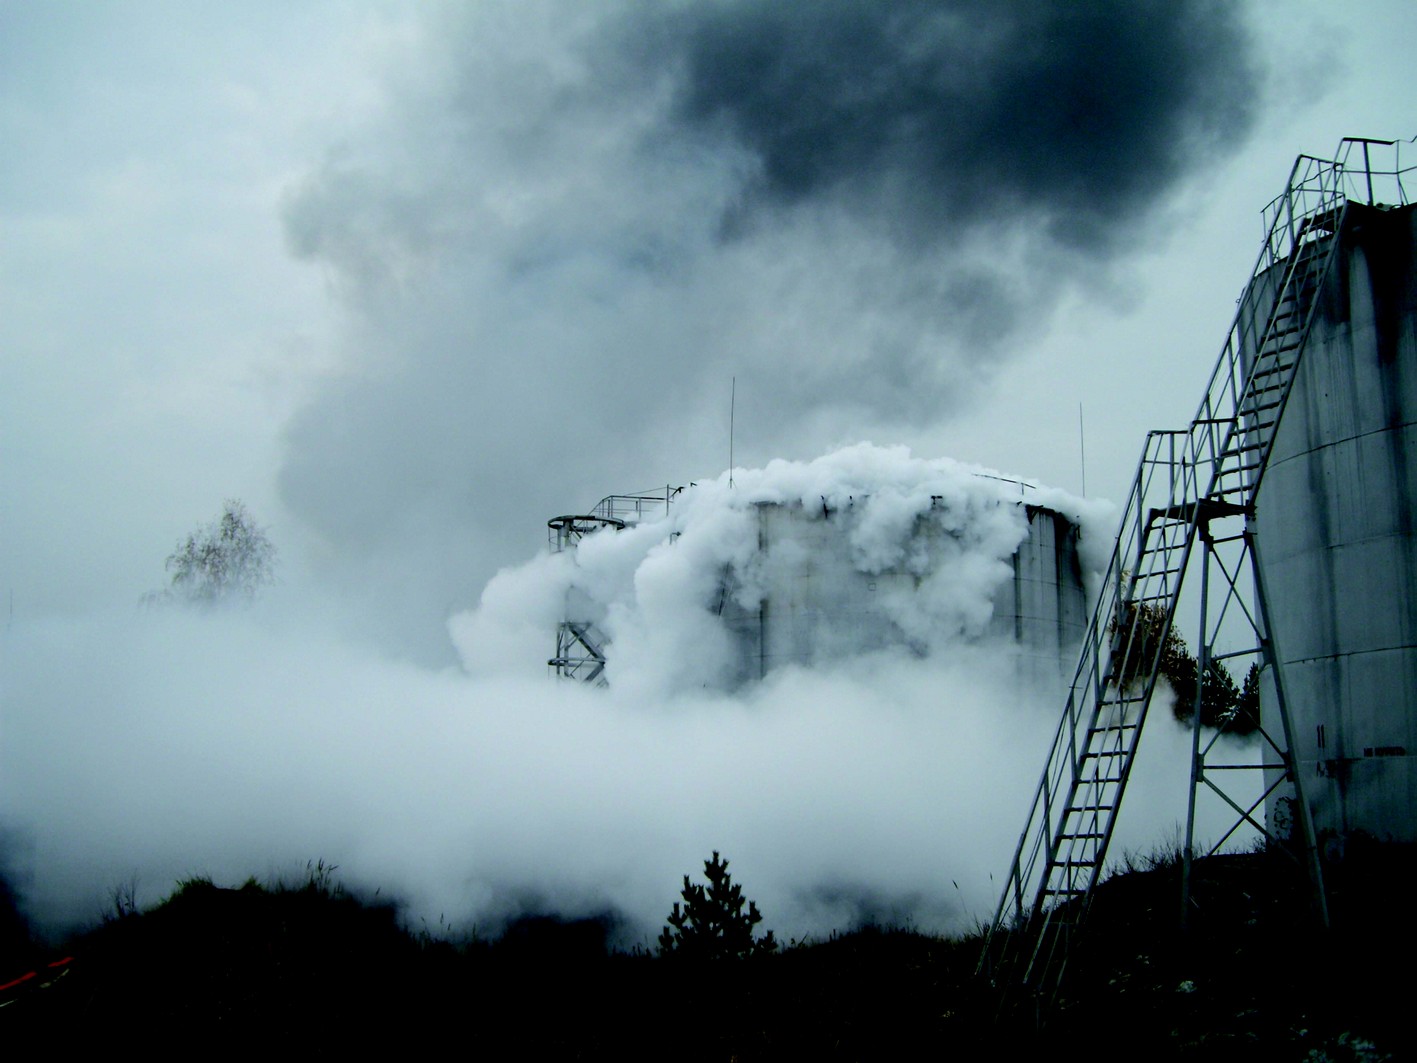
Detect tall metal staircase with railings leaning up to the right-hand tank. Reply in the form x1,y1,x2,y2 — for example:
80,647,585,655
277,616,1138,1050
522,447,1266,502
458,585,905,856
981,140,1417,1009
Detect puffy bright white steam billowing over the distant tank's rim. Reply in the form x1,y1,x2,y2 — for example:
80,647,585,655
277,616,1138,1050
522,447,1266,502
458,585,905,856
451,444,1111,697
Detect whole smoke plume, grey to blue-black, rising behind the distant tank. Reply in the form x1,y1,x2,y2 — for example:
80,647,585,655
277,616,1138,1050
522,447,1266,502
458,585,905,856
281,0,1257,653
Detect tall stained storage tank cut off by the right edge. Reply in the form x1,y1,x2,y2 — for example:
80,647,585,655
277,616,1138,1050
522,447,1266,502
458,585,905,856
1247,204,1417,840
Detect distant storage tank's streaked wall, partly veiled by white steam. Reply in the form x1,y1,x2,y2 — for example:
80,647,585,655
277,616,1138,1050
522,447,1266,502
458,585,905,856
720,500,1087,686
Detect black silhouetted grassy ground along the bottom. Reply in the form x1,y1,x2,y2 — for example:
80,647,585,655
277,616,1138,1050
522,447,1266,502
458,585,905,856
0,839,1417,1060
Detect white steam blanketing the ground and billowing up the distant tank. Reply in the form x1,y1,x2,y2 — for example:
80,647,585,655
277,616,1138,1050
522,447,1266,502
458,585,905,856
0,446,1241,943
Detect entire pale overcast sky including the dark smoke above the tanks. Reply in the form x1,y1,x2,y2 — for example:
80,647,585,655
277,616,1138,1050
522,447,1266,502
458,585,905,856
0,0,1417,935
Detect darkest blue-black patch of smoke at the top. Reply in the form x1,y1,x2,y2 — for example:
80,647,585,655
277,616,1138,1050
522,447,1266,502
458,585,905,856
625,0,1258,251
